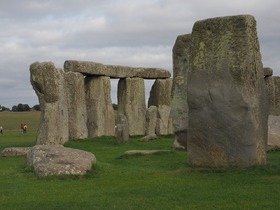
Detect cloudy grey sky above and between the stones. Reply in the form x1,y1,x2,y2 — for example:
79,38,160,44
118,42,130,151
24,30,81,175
0,0,280,108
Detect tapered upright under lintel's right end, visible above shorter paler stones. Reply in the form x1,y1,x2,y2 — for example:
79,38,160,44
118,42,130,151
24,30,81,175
148,78,172,107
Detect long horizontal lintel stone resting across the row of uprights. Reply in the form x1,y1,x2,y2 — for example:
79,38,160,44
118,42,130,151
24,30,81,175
64,60,171,79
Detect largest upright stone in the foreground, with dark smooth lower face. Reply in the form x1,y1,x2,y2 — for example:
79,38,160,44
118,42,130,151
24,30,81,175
187,15,268,167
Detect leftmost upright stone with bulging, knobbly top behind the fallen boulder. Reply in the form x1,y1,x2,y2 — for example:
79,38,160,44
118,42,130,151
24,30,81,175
30,62,69,145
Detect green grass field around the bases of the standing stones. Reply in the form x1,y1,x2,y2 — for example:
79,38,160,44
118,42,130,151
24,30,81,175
0,110,280,210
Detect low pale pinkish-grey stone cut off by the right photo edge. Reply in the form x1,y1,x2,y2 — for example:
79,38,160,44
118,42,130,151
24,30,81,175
267,115,280,148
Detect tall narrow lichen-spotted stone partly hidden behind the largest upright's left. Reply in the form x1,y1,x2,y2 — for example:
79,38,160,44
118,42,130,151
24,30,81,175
171,34,191,148
